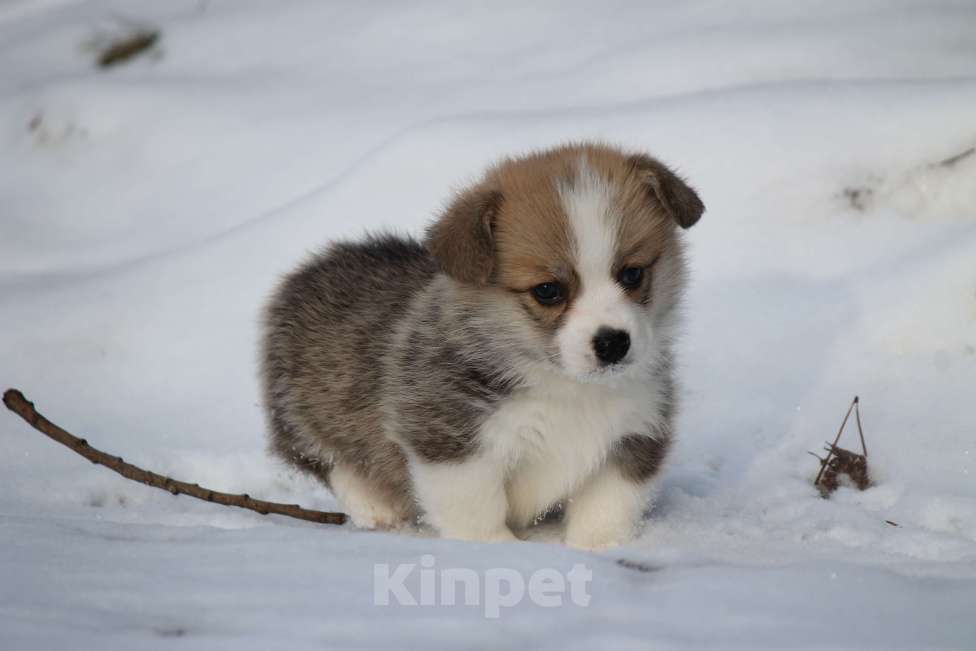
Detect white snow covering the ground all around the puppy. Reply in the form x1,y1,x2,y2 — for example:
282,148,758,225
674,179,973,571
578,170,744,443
0,0,976,649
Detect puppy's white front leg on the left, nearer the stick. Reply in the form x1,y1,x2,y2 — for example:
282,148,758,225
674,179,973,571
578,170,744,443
410,454,518,542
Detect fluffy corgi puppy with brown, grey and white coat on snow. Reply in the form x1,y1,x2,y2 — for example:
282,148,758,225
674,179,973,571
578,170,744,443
262,144,704,549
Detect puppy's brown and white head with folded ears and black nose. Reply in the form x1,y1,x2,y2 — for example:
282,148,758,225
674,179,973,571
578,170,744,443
427,145,704,381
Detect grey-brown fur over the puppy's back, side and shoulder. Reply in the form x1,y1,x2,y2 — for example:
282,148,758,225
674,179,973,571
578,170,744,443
261,235,517,513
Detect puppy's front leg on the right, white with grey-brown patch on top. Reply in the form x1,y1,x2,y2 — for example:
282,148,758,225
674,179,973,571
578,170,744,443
566,428,671,549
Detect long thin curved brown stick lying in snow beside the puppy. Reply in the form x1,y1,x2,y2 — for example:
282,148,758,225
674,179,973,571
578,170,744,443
3,389,346,524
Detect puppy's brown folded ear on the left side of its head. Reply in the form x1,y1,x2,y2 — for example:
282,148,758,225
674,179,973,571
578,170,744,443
427,187,502,285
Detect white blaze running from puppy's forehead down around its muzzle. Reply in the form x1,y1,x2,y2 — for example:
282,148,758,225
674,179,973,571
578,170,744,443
557,157,642,376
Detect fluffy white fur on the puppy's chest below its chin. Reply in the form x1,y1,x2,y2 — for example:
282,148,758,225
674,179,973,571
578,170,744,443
480,374,660,525
